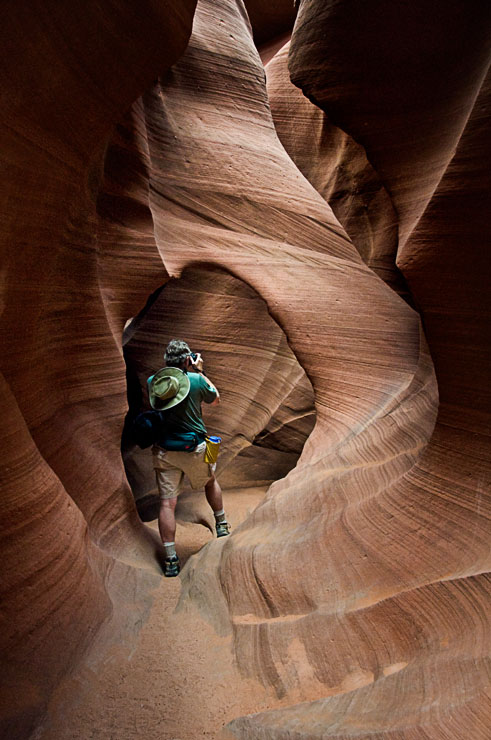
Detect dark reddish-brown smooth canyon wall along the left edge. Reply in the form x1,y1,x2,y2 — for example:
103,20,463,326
0,0,196,737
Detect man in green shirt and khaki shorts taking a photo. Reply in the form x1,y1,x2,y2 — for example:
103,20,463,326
148,339,230,577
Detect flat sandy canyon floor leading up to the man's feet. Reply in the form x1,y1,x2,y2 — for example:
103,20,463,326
35,488,277,740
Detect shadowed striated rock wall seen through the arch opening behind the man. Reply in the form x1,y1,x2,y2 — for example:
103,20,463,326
122,265,315,528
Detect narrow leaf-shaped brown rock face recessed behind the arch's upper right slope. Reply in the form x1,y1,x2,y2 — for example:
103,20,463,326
266,42,410,300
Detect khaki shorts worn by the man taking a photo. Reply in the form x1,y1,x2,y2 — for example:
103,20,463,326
152,442,216,499
